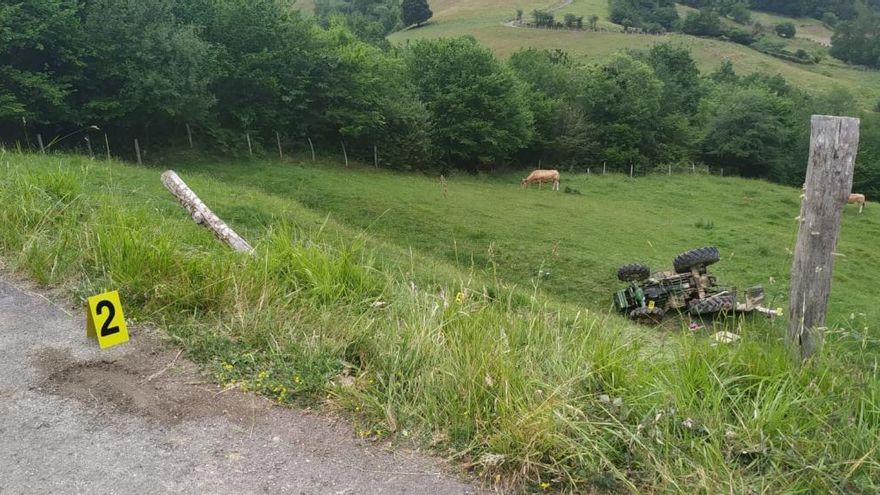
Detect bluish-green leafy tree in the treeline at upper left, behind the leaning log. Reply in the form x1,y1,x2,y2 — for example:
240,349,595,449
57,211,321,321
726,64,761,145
77,0,215,141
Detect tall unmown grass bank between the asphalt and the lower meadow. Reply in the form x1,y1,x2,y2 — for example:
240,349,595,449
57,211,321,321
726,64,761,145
0,156,880,493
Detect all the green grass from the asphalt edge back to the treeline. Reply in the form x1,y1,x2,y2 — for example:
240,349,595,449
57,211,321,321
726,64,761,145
0,154,880,493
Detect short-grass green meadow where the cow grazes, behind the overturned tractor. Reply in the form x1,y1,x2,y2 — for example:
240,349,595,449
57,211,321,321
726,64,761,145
172,163,880,330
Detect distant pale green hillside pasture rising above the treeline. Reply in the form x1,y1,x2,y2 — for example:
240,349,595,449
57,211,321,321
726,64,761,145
390,0,880,108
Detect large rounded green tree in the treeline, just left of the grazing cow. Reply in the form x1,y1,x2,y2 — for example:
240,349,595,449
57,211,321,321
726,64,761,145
406,37,533,170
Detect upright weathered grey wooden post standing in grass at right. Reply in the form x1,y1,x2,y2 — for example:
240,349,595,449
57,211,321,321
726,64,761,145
788,115,859,360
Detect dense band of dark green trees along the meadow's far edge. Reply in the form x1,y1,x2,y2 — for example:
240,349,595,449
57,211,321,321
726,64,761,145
0,0,880,195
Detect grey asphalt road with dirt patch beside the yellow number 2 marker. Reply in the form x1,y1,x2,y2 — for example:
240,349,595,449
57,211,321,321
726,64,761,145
0,277,479,495
